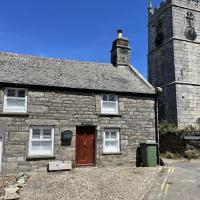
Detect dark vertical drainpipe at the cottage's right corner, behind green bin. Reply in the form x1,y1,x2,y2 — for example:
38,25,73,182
155,87,162,165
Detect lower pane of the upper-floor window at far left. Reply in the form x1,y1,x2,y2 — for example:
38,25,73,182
7,98,25,111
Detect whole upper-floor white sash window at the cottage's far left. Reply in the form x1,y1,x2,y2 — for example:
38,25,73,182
4,88,27,112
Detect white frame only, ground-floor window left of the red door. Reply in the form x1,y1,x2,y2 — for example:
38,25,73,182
28,126,54,157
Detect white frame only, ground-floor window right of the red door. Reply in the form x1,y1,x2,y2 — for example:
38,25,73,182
103,128,121,154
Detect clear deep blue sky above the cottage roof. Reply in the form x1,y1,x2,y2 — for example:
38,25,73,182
0,0,160,77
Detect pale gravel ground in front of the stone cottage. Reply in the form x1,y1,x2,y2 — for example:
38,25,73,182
21,167,161,200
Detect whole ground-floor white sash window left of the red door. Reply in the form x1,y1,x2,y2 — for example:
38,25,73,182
29,126,54,156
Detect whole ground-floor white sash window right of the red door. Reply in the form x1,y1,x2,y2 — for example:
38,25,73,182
103,129,120,153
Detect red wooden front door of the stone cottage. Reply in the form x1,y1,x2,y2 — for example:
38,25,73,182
76,127,95,166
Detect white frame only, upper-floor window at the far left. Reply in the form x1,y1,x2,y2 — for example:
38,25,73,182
3,88,28,113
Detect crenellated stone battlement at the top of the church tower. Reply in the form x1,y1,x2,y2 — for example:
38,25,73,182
148,0,200,21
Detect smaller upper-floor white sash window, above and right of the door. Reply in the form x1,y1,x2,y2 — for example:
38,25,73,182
101,94,118,114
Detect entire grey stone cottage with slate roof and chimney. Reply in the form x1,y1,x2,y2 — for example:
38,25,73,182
0,31,157,172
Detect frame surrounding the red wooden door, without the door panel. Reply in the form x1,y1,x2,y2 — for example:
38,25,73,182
75,125,97,167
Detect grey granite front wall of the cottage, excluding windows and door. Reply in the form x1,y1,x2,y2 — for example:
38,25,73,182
0,88,155,172
